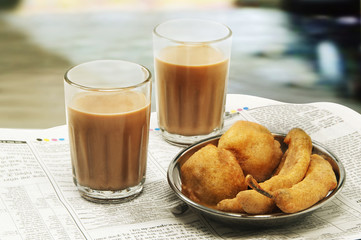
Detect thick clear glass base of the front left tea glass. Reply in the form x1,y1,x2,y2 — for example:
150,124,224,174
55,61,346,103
73,178,145,203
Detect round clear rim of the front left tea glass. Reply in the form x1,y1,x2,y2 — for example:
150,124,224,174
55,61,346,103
64,59,152,92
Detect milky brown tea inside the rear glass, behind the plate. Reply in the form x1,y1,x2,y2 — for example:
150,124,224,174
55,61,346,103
155,44,229,136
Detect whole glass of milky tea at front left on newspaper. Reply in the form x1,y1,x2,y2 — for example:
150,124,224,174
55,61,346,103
64,60,151,203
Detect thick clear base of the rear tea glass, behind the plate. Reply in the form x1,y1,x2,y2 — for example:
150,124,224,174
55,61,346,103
161,128,222,147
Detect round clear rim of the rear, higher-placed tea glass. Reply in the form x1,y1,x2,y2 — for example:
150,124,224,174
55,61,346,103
153,18,232,45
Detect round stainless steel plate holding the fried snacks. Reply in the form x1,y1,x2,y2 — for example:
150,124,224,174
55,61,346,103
167,134,346,227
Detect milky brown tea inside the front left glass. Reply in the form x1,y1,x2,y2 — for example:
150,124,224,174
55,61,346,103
67,90,150,191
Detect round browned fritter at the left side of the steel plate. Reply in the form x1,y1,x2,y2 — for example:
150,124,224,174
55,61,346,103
181,144,247,208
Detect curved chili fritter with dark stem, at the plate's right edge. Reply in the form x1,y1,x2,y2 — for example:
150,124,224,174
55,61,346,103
246,154,337,213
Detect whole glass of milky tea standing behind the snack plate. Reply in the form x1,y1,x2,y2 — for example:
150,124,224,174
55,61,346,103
153,19,232,145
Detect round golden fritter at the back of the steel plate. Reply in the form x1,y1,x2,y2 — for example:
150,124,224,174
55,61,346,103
218,121,282,182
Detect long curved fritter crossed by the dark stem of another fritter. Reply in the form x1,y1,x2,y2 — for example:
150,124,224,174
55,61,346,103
217,128,312,214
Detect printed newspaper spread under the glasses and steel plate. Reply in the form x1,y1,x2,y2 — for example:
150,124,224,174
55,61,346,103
0,95,361,240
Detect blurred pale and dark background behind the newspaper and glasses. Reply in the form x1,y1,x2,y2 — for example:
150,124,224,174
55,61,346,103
0,0,361,128
